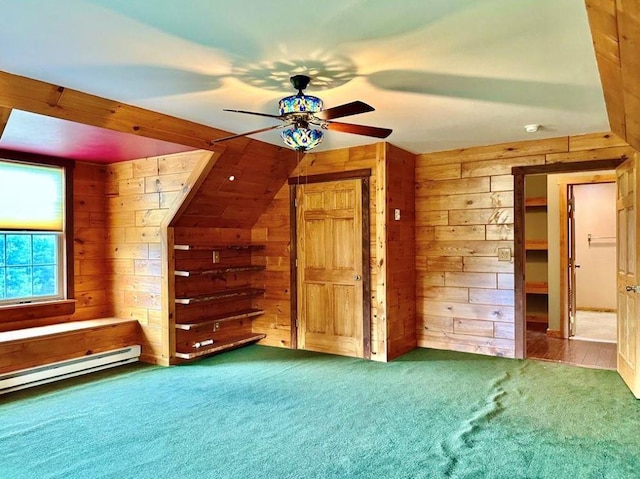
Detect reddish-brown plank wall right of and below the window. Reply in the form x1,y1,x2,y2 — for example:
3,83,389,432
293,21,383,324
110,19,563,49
0,162,113,331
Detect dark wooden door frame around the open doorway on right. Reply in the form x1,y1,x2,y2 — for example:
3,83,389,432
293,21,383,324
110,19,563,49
511,161,627,359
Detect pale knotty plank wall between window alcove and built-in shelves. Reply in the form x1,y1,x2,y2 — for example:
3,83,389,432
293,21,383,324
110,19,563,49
105,151,208,364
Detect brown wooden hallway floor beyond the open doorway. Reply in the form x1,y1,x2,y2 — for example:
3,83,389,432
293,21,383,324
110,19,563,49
527,329,616,370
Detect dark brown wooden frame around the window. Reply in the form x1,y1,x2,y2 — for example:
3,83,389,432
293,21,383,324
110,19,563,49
0,148,75,323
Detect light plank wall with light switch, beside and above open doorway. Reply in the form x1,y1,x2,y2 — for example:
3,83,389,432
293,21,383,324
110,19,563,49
416,129,634,357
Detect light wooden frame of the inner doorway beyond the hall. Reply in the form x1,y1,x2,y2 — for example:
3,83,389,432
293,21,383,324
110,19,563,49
552,174,616,338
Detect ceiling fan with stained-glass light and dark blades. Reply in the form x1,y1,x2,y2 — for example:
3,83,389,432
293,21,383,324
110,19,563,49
211,75,392,151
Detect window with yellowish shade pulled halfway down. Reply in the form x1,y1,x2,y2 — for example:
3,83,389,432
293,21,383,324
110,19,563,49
0,160,67,305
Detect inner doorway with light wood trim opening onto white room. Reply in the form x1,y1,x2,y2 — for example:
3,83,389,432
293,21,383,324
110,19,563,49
548,171,617,343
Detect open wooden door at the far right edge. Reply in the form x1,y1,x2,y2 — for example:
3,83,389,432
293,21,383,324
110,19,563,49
616,154,640,398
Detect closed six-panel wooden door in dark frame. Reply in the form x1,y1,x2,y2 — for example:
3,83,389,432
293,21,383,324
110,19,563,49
296,180,368,357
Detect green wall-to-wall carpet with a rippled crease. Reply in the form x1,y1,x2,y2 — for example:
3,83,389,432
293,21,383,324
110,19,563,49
0,346,640,479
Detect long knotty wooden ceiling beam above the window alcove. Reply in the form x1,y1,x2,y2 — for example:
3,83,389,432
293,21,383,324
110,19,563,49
0,71,240,151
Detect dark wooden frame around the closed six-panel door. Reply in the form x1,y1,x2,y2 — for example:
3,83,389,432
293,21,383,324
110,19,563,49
289,168,371,359
